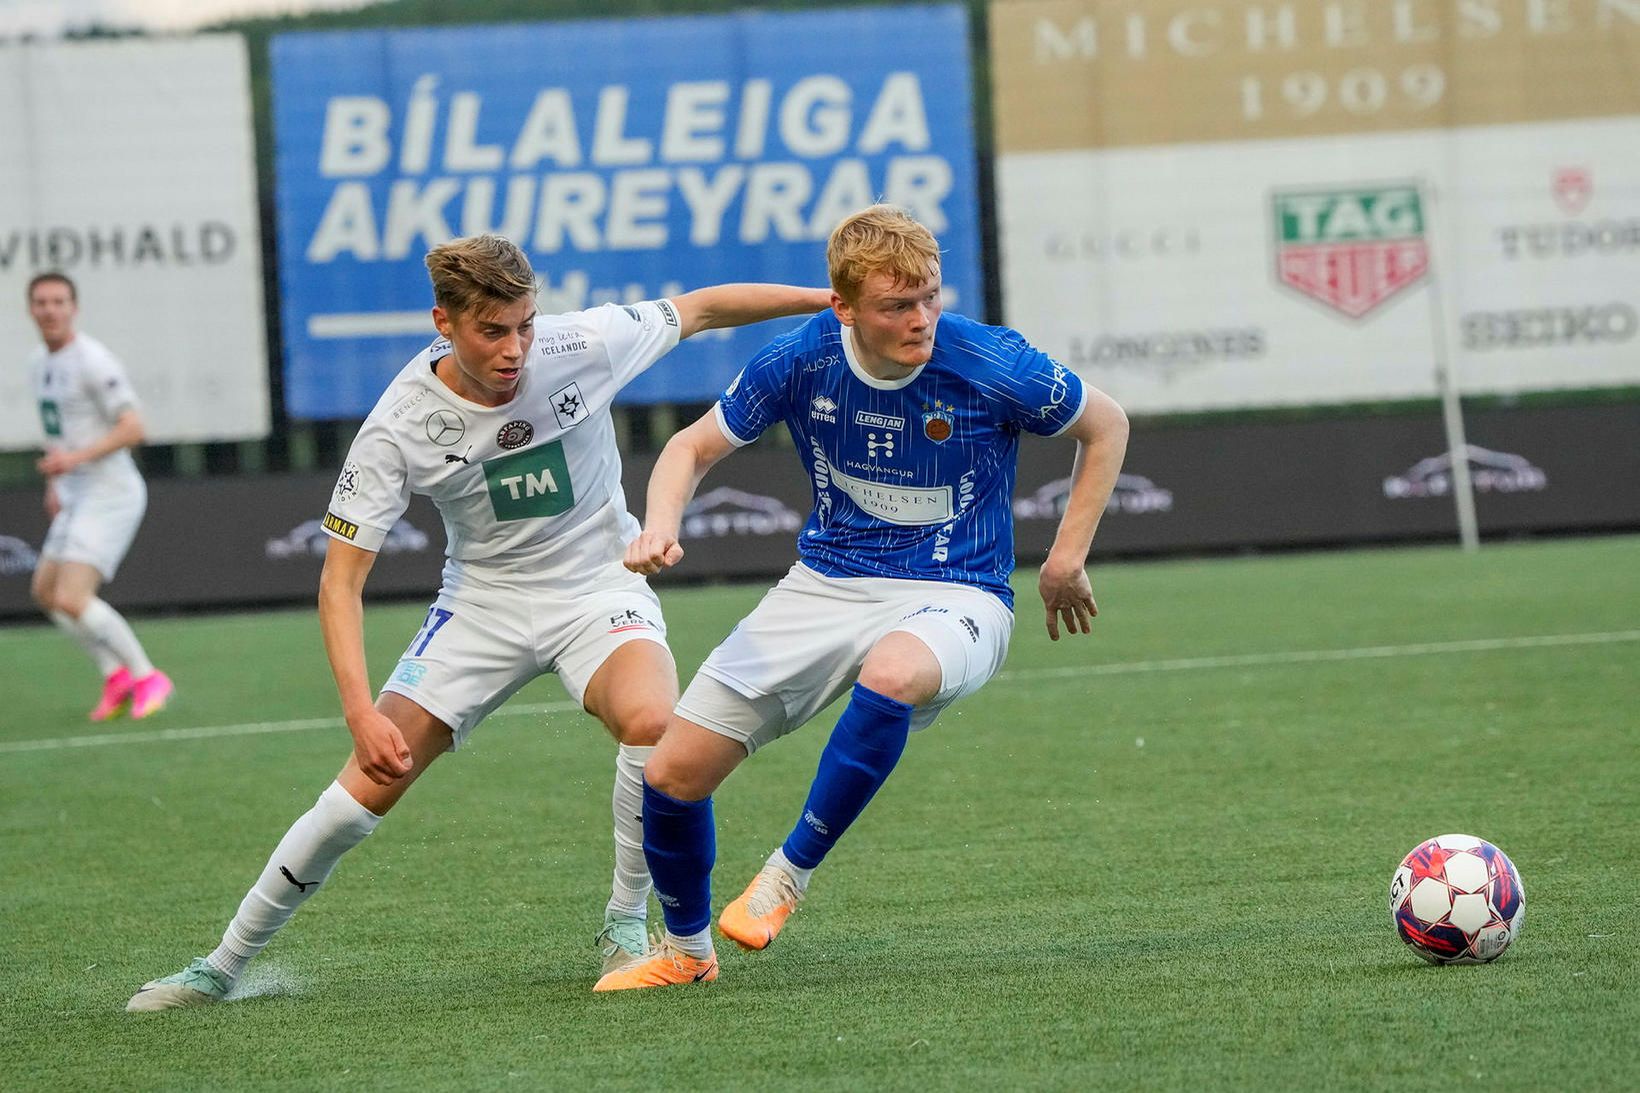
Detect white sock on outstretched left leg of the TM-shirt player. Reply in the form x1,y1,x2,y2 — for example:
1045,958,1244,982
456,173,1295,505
205,781,382,980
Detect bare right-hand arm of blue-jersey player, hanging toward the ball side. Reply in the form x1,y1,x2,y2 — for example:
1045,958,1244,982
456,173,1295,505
1036,387,1128,642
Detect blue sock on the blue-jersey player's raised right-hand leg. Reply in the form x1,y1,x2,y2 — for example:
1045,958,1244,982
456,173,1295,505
777,683,913,866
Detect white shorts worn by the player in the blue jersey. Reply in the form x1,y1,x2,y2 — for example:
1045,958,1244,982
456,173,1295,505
677,563,1014,753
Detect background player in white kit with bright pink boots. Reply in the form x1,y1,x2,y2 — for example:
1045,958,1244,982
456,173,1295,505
28,272,172,720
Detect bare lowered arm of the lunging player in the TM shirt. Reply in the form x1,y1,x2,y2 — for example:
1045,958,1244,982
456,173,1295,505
318,538,412,774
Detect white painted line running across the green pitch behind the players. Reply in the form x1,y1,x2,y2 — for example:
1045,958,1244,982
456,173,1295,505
0,630,1640,755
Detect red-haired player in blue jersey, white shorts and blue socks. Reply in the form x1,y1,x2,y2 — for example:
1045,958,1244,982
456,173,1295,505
595,205,1127,991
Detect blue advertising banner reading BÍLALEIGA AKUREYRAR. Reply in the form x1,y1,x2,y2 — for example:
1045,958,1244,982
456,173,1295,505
272,5,982,418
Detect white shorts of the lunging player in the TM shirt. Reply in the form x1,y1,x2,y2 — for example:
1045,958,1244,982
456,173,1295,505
382,565,666,750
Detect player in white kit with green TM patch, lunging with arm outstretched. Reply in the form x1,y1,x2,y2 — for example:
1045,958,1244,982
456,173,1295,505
126,235,828,1011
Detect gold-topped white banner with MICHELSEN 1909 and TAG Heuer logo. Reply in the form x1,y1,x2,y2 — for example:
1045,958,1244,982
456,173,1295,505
991,0,1640,412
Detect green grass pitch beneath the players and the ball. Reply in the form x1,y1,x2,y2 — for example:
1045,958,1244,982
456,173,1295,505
0,537,1640,1093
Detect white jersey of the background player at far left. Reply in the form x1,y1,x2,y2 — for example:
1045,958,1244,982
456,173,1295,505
30,333,143,504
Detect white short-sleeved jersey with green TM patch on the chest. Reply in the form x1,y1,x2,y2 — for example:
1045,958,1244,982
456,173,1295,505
323,300,681,584
